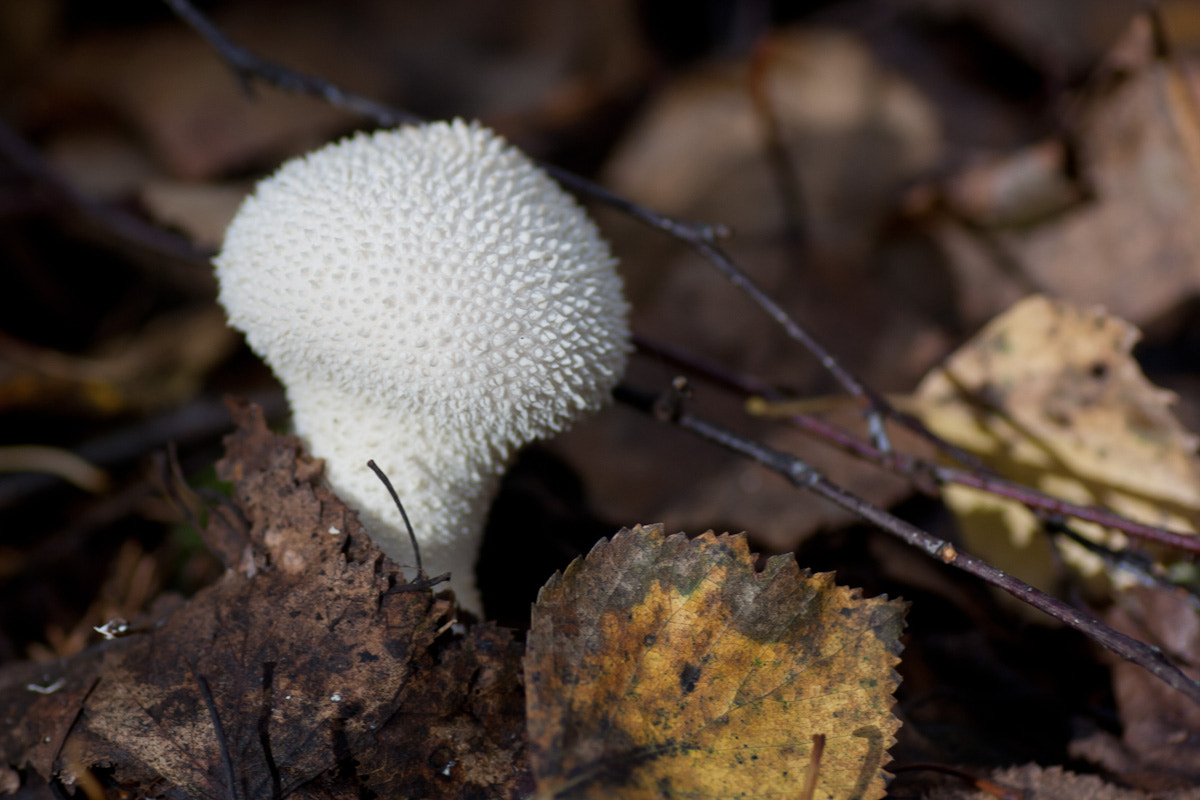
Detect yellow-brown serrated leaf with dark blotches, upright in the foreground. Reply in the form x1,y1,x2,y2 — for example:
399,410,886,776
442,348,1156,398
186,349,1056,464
526,525,904,799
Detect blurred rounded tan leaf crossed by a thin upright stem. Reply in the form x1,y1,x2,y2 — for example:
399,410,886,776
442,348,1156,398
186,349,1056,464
605,28,941,252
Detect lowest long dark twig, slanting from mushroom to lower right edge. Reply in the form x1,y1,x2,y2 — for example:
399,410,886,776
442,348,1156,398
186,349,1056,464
616,385,1200,704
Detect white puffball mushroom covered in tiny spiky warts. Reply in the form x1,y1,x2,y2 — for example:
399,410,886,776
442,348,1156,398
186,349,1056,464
215,120,630,610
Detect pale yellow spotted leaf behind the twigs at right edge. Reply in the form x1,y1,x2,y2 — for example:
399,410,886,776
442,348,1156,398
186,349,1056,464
914,296,1200,587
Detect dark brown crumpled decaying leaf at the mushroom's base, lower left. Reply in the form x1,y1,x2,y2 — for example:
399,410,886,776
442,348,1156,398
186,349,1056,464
0,407,524,798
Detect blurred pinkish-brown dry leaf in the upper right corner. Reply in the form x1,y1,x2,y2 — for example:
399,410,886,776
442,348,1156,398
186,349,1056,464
937,18,1200,325
